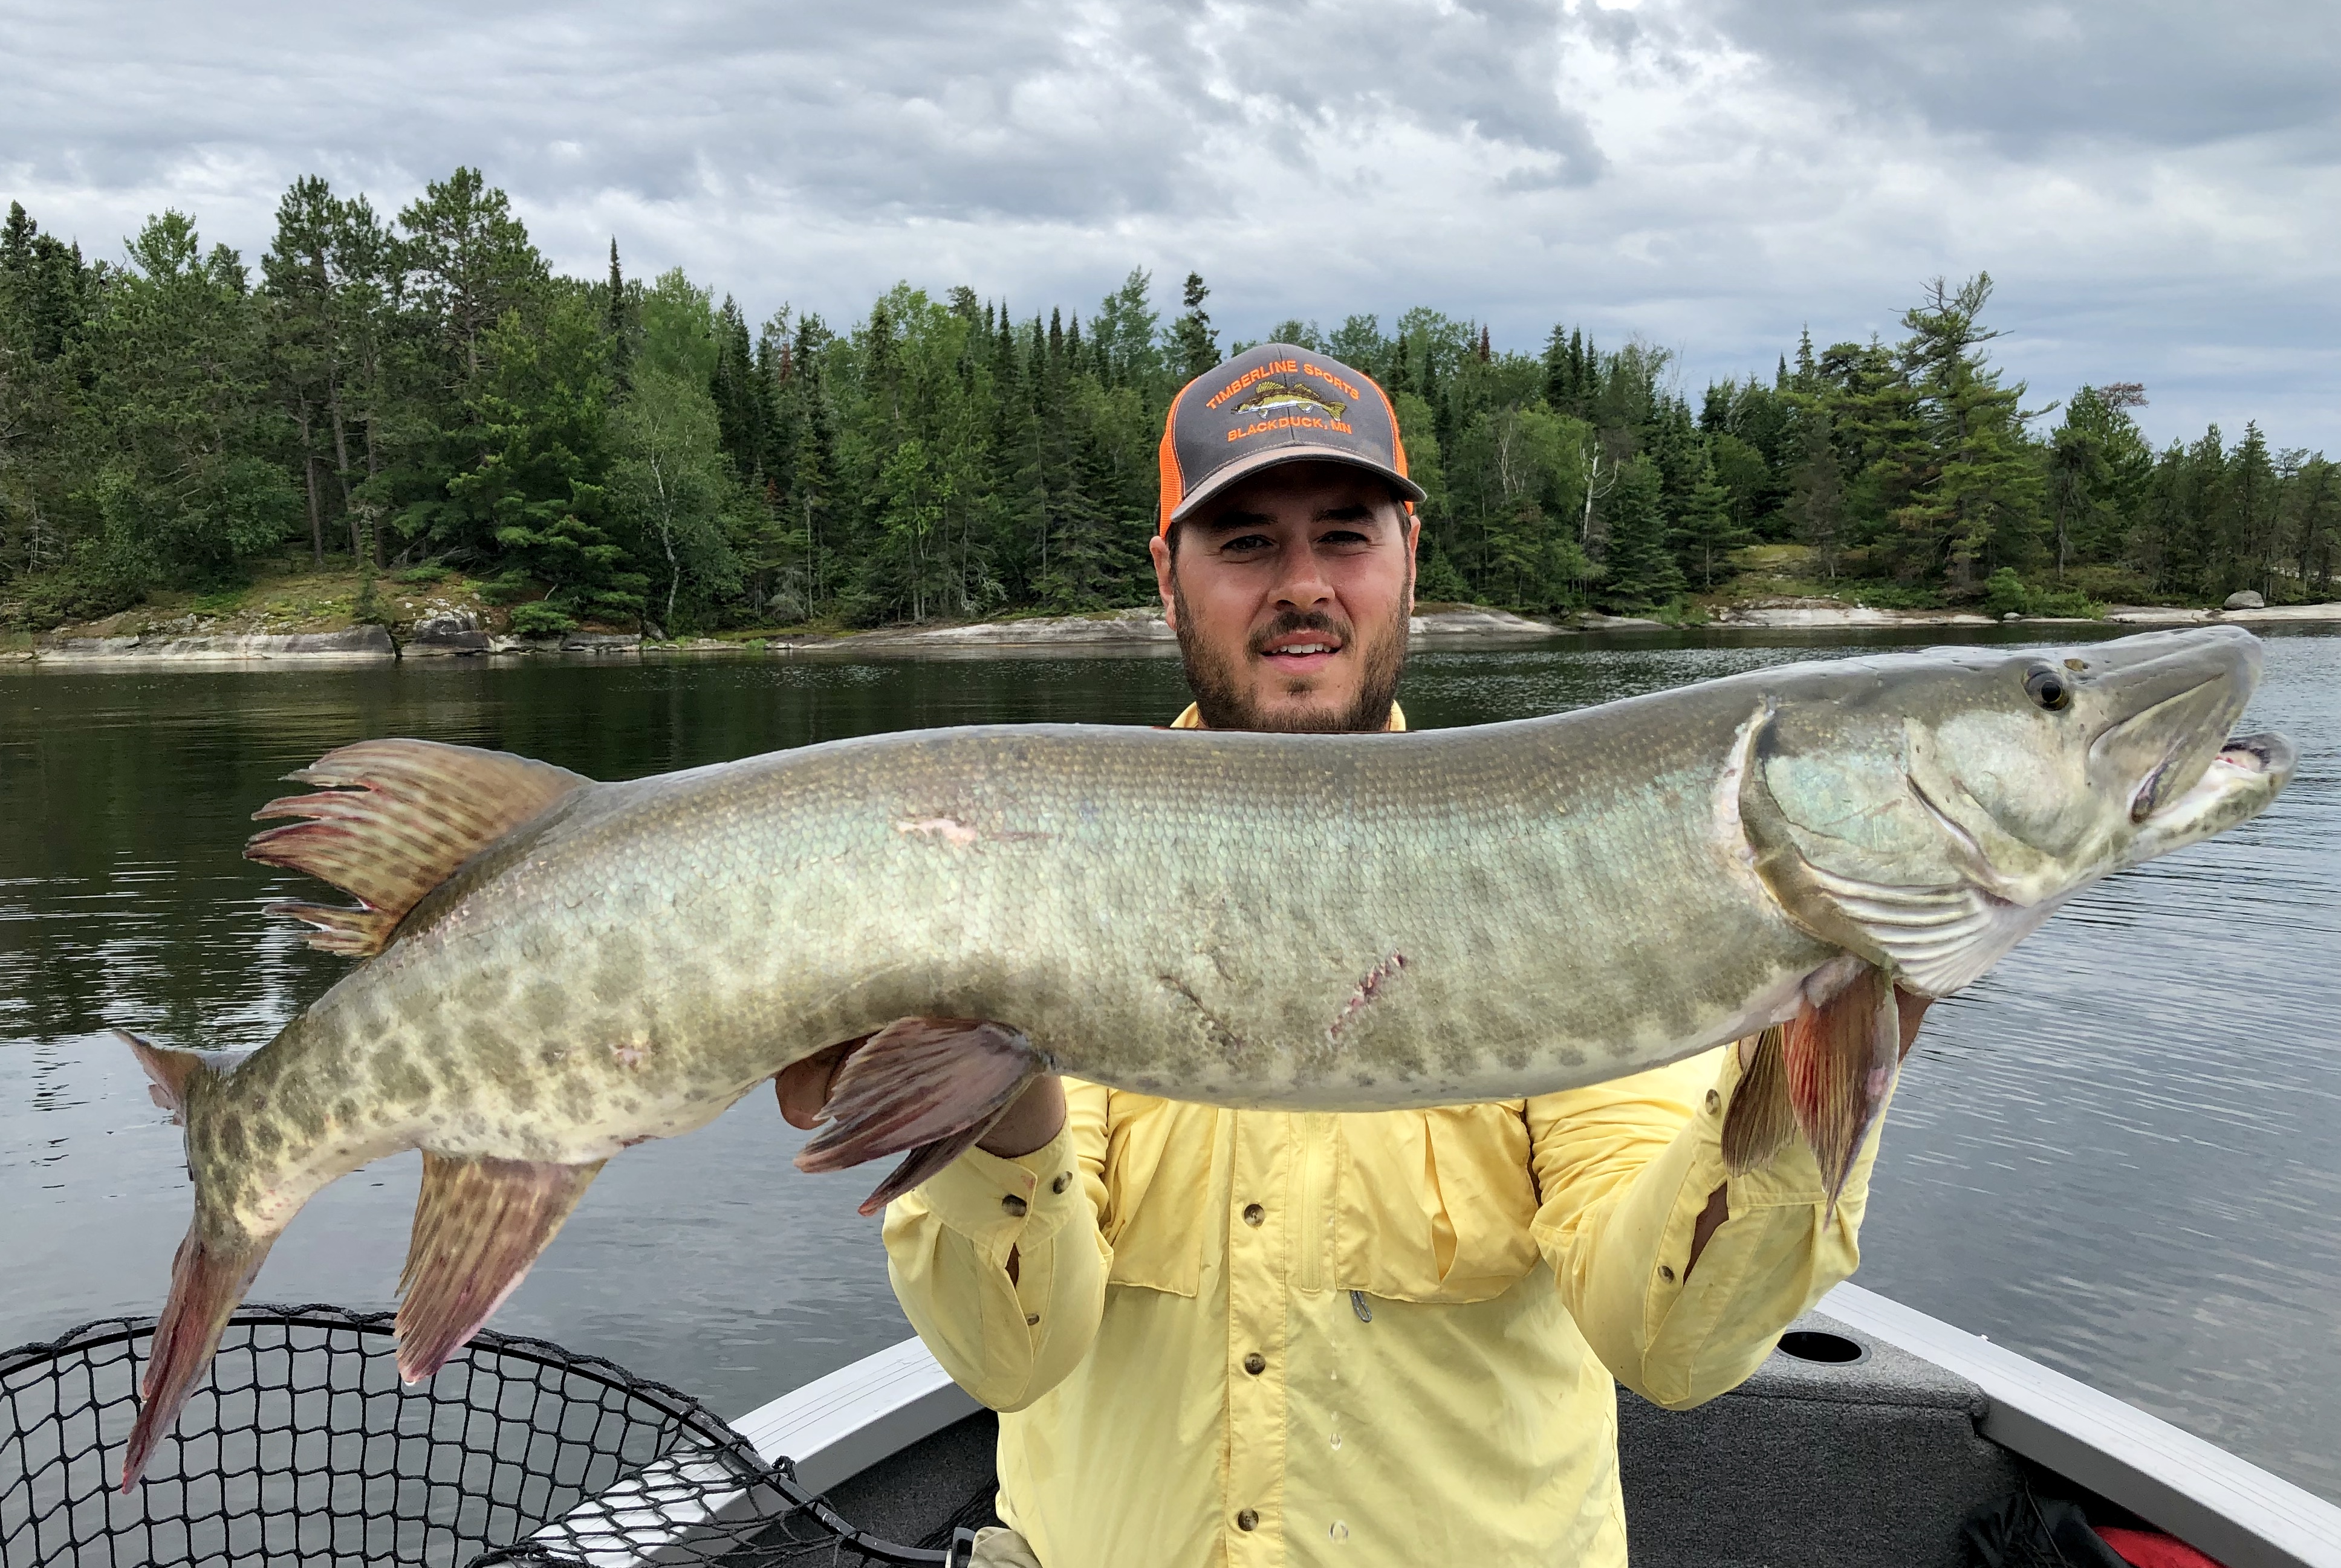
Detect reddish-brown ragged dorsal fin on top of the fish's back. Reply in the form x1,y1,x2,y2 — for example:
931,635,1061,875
244,739,593,957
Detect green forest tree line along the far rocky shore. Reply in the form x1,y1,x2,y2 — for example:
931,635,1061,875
0,169,2341,634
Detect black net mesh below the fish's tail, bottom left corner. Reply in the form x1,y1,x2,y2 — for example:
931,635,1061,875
0,1306,967,1568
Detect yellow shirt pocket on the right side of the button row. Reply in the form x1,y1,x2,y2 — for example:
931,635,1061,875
1332,1100,1538,1304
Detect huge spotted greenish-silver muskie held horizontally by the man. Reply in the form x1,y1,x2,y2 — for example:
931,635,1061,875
122,627,2294,1486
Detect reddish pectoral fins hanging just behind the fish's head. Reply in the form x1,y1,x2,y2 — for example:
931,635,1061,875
1723,964,1901,1224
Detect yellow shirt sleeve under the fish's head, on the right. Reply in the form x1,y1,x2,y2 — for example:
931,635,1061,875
1528,1046,1885,1409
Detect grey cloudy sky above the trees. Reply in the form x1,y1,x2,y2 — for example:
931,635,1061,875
0,0,2341,452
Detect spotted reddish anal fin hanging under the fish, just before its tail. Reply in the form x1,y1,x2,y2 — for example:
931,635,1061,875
398,1149,602,1383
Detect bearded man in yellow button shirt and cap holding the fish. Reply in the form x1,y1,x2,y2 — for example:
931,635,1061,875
779,344,1920,1568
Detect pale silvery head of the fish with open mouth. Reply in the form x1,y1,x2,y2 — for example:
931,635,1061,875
1735,627,2294,997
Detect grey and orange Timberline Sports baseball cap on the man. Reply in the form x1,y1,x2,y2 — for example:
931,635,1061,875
1159,344,1423,534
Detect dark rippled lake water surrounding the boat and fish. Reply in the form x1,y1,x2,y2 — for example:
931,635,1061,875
0,632,2341,1500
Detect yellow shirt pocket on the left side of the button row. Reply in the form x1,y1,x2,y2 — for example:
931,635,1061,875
1098,1090,1224,1297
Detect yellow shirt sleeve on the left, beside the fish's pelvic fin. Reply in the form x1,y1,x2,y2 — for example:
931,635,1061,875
885,1084,1109,1411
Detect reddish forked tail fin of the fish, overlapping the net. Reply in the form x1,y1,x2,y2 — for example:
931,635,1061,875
115,1030,274,1491
